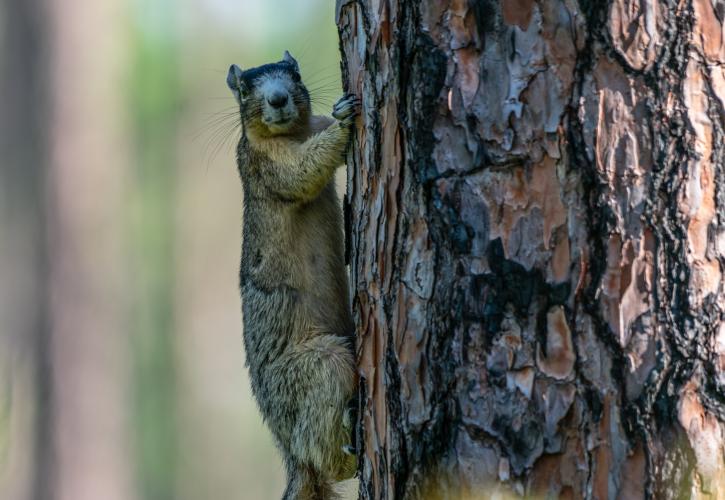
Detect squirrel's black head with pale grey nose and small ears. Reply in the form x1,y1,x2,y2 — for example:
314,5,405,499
227,51,310,137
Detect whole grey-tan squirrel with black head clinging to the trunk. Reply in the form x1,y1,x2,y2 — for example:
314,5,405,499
227,51,359,500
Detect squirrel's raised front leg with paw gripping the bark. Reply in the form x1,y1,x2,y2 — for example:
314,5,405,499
269,95,359,202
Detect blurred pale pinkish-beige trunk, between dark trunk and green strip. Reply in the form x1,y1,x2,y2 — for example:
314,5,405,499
47,0,134,500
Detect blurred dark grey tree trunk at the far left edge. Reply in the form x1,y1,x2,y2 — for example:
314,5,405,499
0,0,54,500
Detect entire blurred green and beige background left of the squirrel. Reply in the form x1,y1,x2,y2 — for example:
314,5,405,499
0,0,340,500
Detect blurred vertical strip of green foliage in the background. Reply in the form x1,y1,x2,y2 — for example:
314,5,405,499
128,1,180,500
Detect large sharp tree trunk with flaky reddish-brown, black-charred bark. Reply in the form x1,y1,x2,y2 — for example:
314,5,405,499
337,0,725,499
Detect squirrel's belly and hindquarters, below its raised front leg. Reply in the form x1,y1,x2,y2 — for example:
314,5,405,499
240,183,355,480
